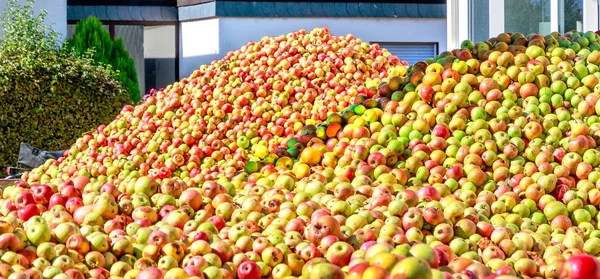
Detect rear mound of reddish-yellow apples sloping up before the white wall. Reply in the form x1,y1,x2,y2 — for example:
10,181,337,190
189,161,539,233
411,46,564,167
24,28,406,186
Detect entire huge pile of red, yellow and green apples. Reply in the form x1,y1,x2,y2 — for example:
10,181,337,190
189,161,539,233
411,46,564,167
5,28,600,279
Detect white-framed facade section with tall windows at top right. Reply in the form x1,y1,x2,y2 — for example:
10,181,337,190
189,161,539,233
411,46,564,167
446,0,600,48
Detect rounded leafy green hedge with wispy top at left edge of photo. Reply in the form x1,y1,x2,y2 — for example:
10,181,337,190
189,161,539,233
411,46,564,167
0,0,130,177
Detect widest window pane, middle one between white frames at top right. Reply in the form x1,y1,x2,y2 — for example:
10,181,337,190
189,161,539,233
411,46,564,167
504,0,551,35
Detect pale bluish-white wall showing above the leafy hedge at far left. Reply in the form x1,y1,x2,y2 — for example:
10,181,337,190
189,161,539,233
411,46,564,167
0,0,67,40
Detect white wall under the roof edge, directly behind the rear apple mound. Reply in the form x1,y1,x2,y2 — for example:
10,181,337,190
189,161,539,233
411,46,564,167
180,17,447,77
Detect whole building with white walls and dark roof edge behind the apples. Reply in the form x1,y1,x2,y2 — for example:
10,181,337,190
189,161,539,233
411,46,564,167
0,0,599,96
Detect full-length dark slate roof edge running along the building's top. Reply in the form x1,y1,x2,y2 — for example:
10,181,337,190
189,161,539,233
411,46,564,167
67,0,446,22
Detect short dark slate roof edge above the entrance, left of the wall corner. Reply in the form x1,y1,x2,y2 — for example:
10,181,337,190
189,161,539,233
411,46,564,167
67,6,178,22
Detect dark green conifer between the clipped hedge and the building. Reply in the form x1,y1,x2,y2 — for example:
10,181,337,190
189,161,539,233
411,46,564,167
67,17,140,103
